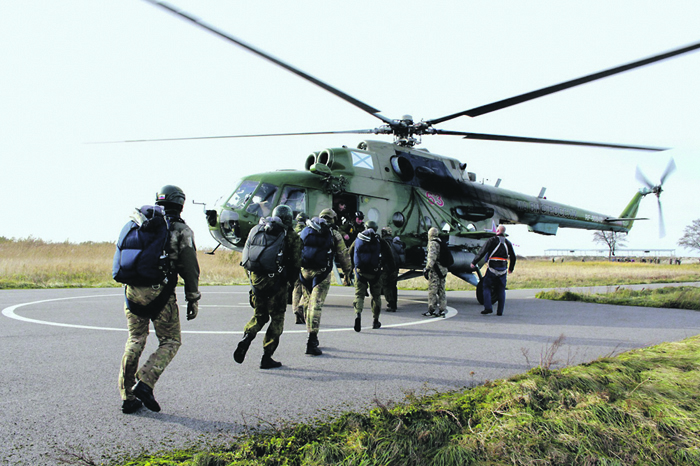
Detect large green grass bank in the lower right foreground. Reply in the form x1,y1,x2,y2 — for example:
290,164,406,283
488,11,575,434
124,337,700,466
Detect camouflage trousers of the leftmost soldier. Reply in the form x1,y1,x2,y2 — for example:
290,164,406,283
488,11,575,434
119,294,182,400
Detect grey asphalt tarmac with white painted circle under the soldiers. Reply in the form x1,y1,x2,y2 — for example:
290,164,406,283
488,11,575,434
0,285,700,465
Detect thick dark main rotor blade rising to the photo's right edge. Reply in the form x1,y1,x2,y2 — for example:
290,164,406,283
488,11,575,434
426,42,700,125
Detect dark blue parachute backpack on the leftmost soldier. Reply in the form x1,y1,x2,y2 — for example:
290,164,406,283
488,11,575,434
112,205,170,286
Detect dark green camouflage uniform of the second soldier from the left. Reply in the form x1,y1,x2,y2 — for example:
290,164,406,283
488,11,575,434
243,228,301,357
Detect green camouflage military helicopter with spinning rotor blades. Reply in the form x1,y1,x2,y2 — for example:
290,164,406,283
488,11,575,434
142,0,700,286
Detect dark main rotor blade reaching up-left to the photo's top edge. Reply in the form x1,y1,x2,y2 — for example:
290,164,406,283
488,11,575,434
145,0,391,123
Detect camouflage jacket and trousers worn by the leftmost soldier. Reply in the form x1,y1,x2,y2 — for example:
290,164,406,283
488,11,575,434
119,217,201,400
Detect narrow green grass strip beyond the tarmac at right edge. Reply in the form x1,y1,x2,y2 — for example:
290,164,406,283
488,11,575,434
535,286,700,311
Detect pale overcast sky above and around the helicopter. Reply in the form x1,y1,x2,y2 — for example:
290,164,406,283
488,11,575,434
0,0,700,255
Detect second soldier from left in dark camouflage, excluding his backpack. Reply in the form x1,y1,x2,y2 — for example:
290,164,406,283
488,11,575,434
233,204,301,369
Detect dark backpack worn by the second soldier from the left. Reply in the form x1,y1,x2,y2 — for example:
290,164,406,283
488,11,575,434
241,217,287,274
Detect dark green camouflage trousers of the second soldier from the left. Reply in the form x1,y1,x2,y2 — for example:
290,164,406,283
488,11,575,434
243,280,288,356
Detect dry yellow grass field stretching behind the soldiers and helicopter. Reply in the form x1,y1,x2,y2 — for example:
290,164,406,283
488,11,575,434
0,237,700,290
